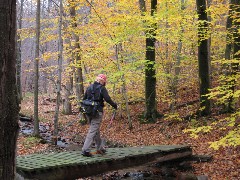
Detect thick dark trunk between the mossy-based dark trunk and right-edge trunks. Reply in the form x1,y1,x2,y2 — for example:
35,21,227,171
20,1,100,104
197,0,211,115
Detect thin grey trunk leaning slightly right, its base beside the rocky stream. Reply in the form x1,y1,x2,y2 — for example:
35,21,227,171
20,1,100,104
52,0,63,145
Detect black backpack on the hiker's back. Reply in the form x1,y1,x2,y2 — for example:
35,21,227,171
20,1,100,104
81,84,102,117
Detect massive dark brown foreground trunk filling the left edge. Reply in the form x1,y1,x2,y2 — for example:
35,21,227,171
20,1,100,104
0,0,19,180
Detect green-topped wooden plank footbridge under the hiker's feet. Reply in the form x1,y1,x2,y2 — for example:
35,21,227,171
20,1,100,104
17,145,192,180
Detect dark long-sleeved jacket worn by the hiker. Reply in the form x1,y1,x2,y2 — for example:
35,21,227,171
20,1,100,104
83,81,117,112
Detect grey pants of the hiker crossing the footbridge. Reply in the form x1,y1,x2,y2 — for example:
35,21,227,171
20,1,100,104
82,112,103,151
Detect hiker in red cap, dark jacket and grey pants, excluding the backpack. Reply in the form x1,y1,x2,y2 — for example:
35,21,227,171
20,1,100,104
82,74,117,157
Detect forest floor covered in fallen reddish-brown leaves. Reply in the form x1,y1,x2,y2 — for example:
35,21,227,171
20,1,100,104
17,96,240,180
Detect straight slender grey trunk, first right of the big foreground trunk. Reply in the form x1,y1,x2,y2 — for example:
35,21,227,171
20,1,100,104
33,0,40,136
